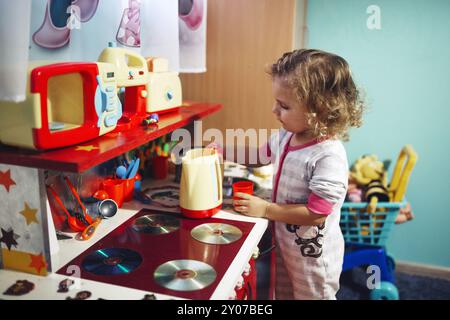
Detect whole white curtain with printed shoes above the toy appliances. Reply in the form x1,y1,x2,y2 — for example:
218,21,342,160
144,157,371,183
0,0,206,102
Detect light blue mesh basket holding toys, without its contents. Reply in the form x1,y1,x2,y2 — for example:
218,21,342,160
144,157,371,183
339,202,406,246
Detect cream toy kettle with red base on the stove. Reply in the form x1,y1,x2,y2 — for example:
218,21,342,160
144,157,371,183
180,148,222,219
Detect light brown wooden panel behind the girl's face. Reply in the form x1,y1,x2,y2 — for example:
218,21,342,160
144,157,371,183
181,0,296,140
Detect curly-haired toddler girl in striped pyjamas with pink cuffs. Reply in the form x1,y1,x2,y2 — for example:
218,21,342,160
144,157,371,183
234,49,363,299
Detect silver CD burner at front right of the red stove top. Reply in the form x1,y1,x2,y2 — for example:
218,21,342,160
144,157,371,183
153,260,217,291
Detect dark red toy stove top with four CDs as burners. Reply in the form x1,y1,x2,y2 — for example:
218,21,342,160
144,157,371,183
57,209,254,300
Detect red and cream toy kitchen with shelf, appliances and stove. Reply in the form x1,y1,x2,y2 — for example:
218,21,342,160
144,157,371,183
0,45,267,300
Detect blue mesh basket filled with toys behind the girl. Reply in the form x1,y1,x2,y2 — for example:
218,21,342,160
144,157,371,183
341,145,417,245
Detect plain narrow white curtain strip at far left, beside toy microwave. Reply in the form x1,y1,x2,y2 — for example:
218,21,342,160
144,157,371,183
0,0,31,102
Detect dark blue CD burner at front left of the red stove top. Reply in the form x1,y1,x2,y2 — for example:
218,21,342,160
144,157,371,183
81,248,142,276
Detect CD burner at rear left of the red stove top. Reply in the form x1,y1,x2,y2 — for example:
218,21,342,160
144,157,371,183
132,213,180,234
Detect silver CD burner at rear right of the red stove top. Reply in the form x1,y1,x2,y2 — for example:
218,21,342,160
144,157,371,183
191,223,242,244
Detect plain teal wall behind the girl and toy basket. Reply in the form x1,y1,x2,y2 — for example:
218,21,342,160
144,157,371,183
306,0,450,267
